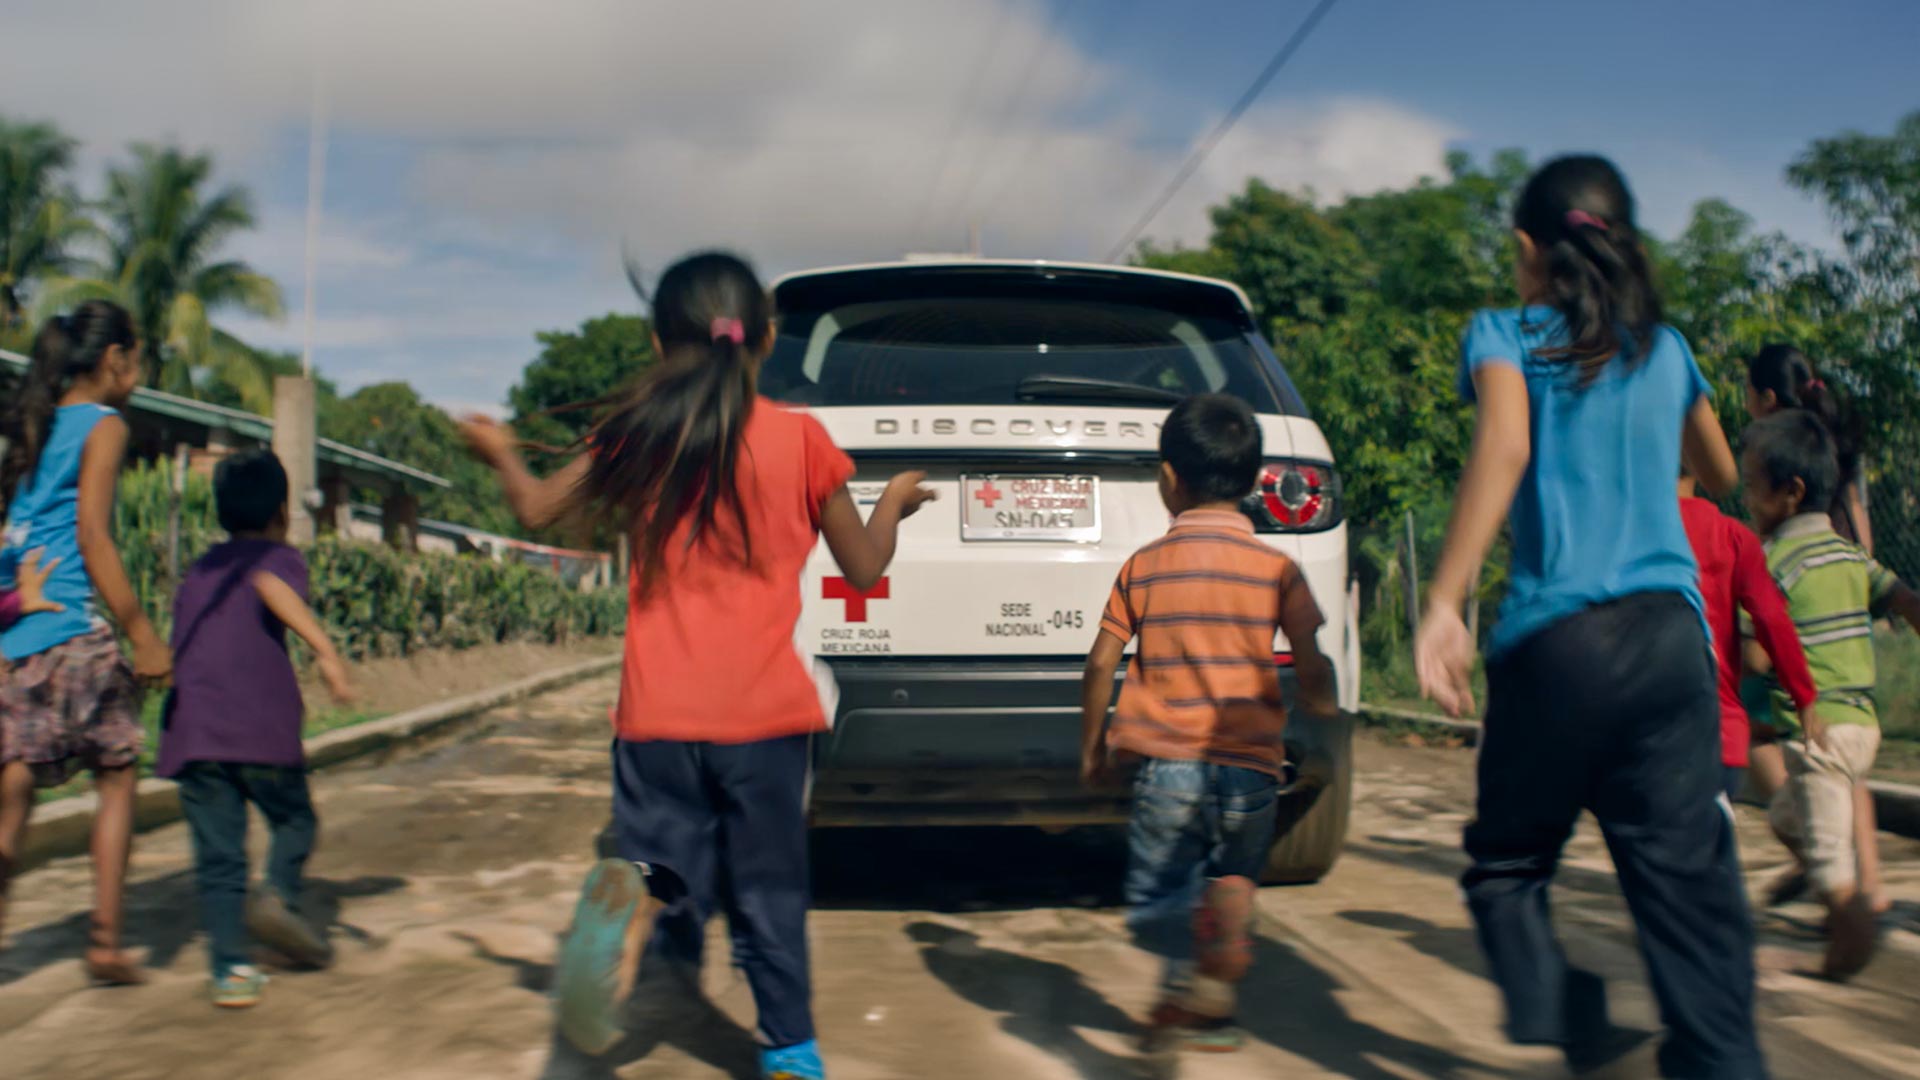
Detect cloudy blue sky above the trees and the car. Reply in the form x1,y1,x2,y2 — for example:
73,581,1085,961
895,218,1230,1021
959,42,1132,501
0,0,1920,411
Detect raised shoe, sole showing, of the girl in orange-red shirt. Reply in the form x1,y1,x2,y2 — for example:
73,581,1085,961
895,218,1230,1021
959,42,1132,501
553,859,660,1057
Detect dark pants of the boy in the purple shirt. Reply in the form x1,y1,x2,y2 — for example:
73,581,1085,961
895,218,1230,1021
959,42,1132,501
177,761,319,978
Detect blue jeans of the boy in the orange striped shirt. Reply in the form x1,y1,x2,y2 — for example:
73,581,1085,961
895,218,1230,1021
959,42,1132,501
1125,757,1281,990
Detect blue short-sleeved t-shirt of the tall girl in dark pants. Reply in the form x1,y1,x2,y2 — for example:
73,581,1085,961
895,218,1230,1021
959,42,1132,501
1459,307,1709,657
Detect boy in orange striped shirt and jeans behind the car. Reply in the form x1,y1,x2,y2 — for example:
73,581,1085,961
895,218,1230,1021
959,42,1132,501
1081,394,1336,1053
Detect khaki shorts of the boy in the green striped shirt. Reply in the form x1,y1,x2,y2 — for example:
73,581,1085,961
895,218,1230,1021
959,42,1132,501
1766,724,1880,894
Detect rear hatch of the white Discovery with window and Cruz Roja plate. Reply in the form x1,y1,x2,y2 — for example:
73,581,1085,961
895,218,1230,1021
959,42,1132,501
760,265,1336,659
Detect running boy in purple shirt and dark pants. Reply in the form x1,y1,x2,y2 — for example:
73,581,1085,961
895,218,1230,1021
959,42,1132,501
154,452,353,1009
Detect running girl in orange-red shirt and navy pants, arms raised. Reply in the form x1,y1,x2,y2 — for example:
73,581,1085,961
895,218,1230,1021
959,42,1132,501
465,254,933,1080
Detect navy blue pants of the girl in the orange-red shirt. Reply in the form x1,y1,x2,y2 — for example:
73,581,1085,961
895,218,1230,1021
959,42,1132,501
612,736,814,1047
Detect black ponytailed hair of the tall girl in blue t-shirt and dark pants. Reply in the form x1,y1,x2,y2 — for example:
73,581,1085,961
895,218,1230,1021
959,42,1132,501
1513,154,1663,388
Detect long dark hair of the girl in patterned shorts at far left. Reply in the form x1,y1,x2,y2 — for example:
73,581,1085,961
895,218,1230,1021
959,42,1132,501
0,300,136,503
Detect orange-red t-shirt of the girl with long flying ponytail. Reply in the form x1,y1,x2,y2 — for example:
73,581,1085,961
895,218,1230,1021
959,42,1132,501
614,398,852,742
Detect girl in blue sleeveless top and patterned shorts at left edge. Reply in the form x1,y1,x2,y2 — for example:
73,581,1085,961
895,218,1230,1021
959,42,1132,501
0,300,173,984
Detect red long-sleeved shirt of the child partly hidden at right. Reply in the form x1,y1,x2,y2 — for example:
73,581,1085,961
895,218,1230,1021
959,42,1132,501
1680,498,1814,767
